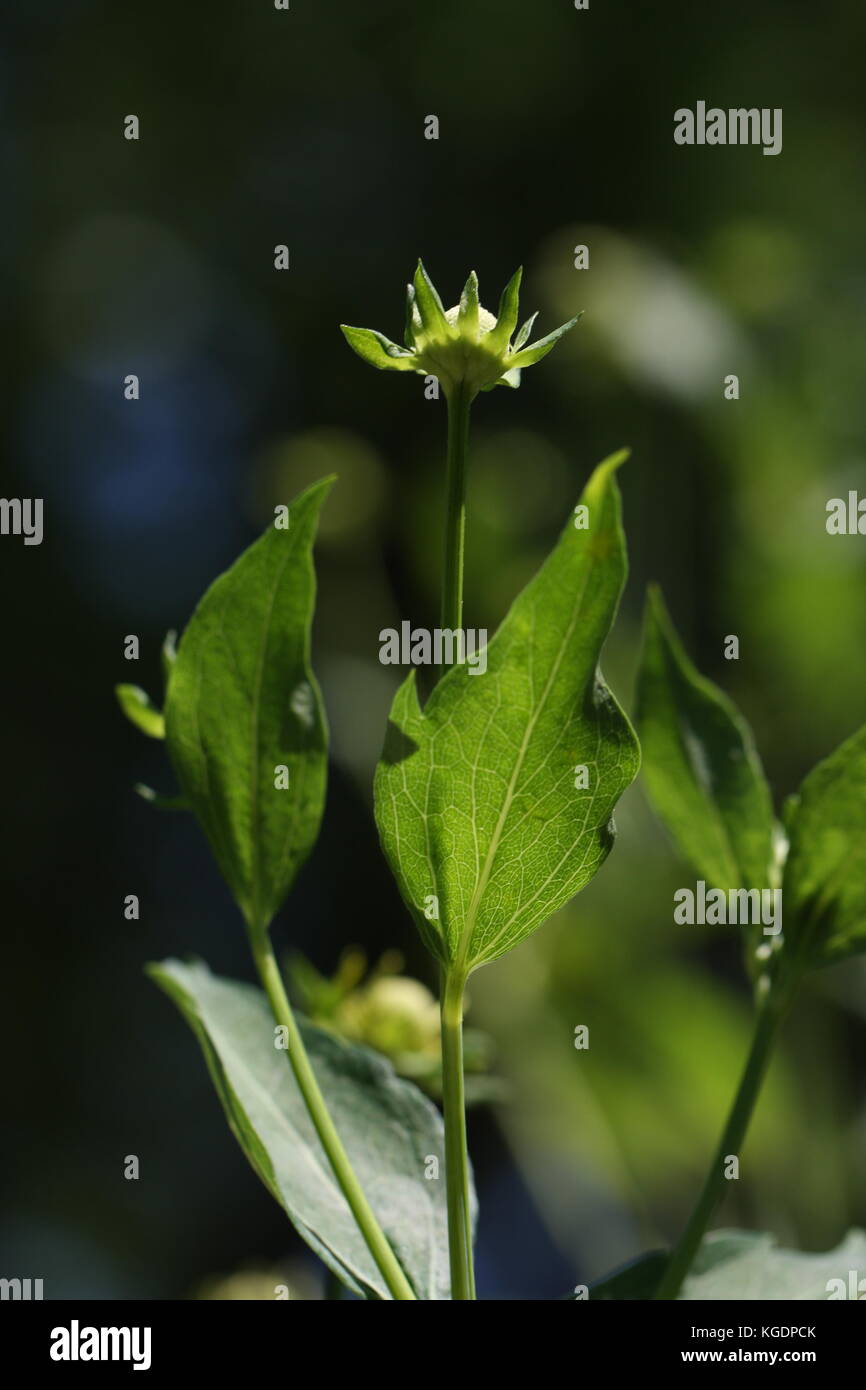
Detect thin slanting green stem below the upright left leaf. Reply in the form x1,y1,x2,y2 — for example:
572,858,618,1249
250,929,416,1301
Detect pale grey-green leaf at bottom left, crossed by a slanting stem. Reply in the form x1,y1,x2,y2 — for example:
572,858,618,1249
149,960,461,1300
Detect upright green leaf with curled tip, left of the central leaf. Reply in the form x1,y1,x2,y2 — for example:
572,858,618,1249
165,478,332,926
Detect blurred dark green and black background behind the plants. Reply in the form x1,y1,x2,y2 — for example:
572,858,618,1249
0,0,866,1298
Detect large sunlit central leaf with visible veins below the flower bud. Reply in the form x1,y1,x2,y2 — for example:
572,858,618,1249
375,453,639,972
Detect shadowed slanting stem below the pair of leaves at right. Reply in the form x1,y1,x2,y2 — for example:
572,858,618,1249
653,995,787,1298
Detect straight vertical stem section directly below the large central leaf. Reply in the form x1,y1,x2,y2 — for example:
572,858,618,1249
441,973,475,1301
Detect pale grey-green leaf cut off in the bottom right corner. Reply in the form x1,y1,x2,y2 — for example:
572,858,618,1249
680,1230,866,1302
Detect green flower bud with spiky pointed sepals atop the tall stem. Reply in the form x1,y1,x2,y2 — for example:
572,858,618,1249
341,261,581,399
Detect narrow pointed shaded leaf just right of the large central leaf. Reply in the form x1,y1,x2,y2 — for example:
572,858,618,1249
637,589,774,891
